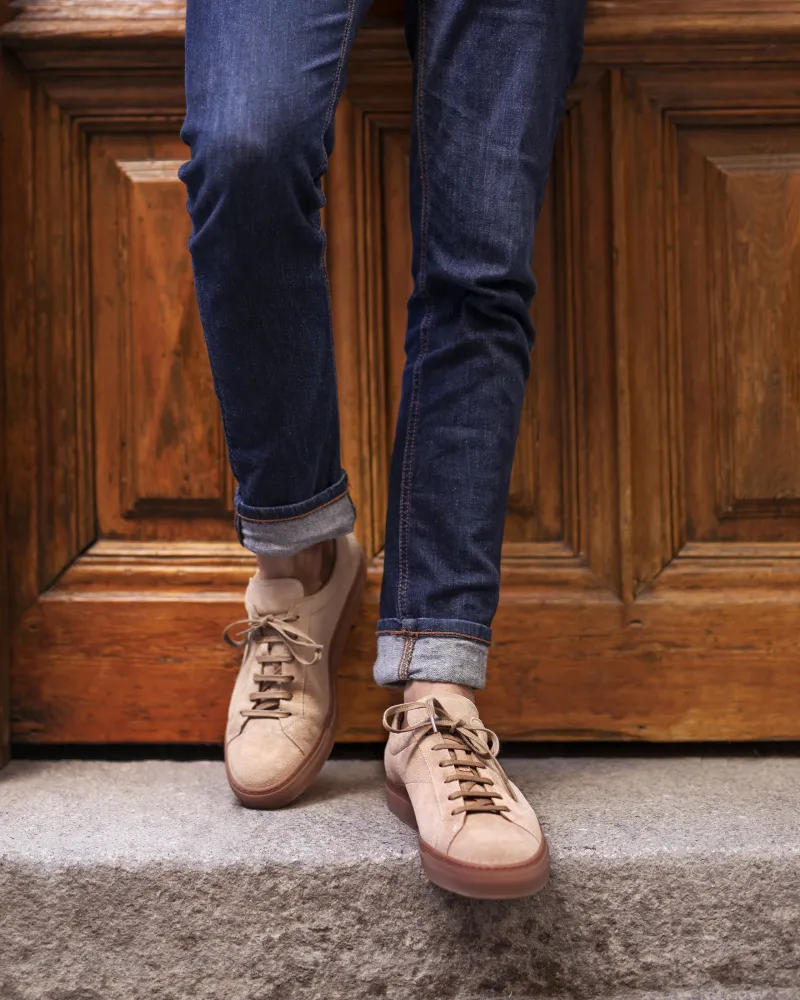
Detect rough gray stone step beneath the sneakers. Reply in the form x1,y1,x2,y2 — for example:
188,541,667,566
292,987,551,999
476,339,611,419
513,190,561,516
0,758,800,1000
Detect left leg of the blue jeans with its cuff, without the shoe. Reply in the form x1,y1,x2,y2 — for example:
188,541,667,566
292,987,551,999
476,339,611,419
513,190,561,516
181,0,374,556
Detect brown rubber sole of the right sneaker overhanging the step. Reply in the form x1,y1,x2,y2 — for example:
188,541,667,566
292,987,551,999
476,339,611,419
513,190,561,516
386,778,550,899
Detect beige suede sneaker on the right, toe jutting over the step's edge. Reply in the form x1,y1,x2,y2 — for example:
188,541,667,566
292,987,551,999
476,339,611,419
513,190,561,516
383,695,550,899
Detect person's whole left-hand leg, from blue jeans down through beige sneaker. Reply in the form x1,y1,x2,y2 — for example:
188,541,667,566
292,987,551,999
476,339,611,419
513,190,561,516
181,0,368,806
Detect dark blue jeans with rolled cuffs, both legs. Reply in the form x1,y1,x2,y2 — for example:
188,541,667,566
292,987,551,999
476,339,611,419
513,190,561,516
181,0,585,687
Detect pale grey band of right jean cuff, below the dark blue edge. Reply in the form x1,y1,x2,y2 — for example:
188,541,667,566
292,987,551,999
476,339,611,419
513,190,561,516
373,634,489,689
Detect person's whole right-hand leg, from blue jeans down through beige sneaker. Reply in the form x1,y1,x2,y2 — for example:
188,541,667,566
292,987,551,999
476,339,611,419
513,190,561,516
375,0,584,895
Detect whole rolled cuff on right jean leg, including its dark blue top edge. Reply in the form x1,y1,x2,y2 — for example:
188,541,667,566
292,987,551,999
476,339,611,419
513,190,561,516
373,618,492,689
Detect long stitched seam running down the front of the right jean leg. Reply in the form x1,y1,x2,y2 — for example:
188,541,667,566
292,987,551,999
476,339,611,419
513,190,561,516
397,0,433,617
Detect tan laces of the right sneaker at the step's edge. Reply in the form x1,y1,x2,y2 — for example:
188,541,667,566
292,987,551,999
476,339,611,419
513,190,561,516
383,698,517,816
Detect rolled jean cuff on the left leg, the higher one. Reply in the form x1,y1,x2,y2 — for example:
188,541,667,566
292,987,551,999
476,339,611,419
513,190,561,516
235,475,356,556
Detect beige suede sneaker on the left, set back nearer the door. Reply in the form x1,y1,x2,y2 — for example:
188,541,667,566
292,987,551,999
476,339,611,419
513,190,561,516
225,535,365,809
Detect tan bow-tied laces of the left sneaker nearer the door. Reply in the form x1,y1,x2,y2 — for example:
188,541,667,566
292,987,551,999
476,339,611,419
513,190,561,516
222,613,322,719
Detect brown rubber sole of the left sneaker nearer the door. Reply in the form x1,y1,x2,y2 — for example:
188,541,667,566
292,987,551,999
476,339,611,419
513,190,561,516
225,555,367,809
